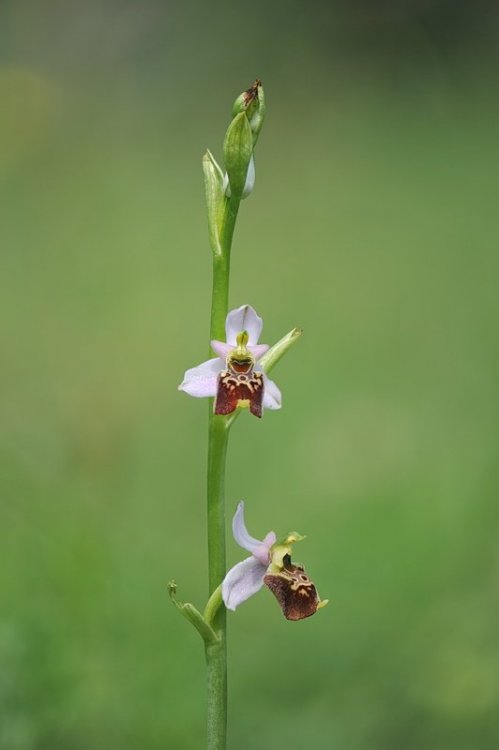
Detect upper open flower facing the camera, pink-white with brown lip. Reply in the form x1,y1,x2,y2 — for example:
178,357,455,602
179,305,281,417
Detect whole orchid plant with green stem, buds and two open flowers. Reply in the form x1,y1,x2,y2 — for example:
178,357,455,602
169,79,327,750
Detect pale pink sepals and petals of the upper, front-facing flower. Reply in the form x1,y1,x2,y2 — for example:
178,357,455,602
178,305,282,410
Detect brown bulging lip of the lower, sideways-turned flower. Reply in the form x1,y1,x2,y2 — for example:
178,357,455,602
263,555,320,620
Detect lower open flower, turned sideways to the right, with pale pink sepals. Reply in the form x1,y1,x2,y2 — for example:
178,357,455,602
222,501,327,620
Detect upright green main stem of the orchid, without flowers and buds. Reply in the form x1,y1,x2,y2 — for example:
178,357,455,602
205,198,239,750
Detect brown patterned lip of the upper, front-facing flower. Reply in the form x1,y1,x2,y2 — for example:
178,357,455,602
215,366,263,417
